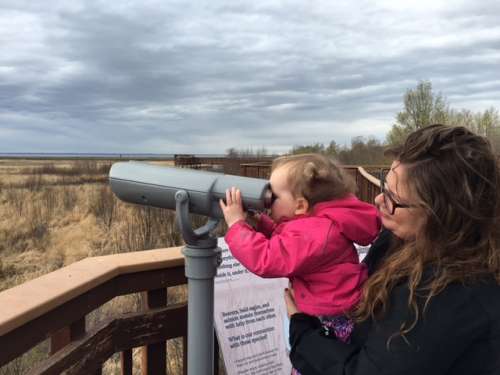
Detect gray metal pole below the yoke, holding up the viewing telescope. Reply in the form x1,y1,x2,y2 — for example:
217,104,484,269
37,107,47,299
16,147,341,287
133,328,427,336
182,245,221,375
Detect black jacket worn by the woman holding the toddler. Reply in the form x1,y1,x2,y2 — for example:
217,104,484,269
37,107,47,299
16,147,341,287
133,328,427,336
290,232,500,375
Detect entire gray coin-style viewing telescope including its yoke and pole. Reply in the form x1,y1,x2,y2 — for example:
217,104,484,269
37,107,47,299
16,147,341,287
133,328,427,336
109,162,273,375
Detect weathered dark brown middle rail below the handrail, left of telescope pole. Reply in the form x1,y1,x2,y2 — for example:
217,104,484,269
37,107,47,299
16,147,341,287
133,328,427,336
30,303,187,375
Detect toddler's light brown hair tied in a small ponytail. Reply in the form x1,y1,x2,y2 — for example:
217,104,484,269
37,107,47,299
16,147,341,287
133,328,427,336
271,154,356,208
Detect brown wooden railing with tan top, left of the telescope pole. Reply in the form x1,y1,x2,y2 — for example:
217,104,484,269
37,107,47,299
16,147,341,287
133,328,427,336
0,248,223,375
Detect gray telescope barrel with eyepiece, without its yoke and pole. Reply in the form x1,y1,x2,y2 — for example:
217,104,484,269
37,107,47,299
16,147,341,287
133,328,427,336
109,161,273,219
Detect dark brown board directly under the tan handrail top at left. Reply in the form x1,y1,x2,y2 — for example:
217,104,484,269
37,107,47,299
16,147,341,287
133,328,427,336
0,266,186,366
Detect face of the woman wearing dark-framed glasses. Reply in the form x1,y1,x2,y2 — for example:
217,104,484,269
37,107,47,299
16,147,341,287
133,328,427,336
375,161,425,240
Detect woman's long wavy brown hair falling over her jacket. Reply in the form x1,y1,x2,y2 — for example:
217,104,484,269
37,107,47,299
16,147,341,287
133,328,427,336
355,125,500,344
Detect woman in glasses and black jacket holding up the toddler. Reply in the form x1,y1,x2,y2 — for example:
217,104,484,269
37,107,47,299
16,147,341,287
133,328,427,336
285,125,500,375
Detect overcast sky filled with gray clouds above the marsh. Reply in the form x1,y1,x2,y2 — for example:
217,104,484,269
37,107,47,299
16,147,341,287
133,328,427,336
0,0,500,153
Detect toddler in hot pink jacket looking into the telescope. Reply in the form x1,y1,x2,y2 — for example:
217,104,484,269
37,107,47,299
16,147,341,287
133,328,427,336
220,154,380,341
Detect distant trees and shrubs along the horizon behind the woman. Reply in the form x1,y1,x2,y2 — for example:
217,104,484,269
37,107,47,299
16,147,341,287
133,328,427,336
227,81,500,165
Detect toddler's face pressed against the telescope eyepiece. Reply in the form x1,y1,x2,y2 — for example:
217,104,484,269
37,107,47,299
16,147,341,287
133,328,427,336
269,165,305,222
